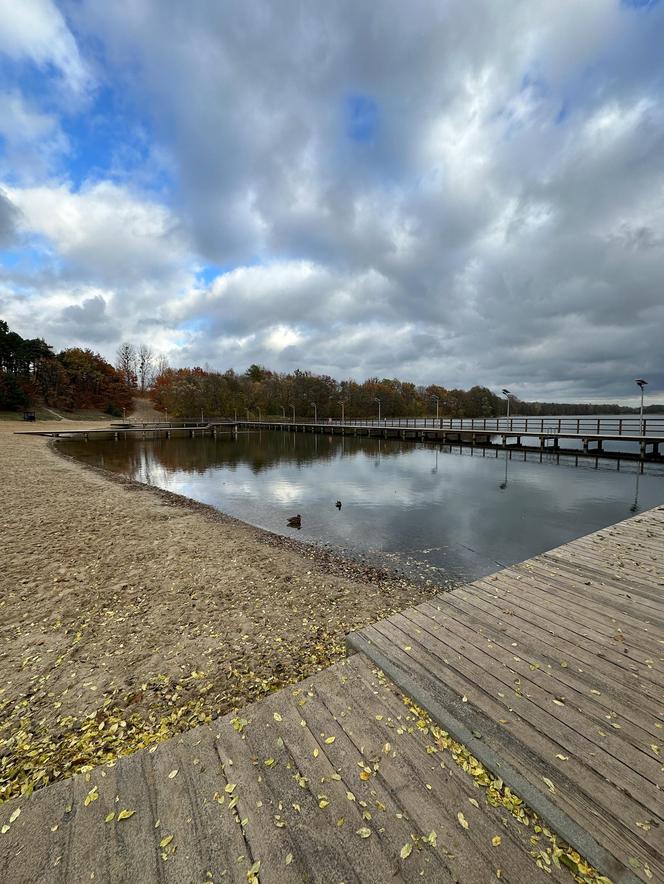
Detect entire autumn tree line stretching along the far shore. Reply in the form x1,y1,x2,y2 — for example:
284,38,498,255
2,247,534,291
0,320,664,420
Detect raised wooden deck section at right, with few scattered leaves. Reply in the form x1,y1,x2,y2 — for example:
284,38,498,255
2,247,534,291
349,508,664,881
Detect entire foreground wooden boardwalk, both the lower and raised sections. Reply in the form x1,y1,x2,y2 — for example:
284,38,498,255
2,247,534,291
0,507,664,884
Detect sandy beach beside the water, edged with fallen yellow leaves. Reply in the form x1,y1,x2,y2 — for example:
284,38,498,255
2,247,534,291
0,421,432,801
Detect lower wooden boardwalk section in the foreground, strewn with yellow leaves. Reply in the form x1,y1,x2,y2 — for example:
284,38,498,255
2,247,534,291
0,655,572,884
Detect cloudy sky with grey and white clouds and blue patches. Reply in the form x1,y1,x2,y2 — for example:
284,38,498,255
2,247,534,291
0,0,664,402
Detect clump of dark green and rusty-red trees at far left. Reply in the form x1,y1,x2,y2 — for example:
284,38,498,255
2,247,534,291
0,319,132,417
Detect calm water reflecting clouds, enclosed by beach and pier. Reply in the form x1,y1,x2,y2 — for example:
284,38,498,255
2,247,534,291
60,431,664,582
